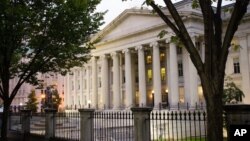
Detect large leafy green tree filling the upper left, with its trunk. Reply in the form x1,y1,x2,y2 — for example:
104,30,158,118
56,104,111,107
0,0,104,140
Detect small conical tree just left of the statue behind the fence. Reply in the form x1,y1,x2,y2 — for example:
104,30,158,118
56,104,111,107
25,90,38,113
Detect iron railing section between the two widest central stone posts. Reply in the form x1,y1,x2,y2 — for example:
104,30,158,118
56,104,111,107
93,111,134,141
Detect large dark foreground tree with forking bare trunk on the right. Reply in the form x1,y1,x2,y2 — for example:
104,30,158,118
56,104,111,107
123,0,249,141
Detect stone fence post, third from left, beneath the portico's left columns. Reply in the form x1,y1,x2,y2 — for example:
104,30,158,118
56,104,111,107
78,109,95,141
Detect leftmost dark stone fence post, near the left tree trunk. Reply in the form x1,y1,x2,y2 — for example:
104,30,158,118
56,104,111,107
21,109,31,140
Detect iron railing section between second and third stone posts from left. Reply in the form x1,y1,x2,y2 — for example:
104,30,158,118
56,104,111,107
55,112,80,141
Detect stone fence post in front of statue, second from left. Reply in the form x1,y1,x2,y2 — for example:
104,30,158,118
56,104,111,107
44,108,57,140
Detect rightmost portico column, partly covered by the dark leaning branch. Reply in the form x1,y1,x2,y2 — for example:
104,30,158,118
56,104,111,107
183,37,198,109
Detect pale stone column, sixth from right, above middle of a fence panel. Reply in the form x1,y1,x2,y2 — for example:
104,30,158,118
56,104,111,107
111,52,121,109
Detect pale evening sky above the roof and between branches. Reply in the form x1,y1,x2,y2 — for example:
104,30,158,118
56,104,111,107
97,0,234,29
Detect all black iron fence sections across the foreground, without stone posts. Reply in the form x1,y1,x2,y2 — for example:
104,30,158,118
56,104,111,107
7,110,206,141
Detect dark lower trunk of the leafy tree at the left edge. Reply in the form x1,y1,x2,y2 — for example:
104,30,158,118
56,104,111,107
1,100,10,141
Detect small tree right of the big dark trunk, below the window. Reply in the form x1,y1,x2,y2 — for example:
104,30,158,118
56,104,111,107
222,77,245,104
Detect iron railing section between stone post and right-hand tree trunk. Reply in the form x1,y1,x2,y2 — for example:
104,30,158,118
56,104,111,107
150,110,206,141
